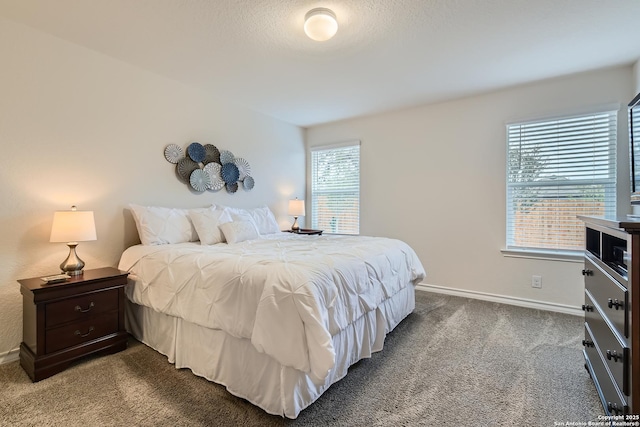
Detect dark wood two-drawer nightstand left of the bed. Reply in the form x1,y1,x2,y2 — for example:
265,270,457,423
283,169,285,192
18,267,128,381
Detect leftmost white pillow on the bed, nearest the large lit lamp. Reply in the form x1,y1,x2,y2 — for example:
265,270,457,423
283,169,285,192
129,204,198,245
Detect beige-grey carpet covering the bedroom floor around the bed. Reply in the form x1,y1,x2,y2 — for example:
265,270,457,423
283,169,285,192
0,292,603,426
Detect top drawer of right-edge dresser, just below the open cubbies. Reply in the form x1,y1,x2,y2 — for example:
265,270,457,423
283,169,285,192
584,258,629,337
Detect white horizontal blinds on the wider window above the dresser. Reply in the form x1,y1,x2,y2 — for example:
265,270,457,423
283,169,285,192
507,111,617,250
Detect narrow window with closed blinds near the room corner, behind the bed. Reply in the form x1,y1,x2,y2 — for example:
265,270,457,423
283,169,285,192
311,142,360,234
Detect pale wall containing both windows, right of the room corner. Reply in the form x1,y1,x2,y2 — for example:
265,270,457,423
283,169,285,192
306,65,634,307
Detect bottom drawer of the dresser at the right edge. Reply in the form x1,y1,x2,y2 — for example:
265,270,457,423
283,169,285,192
584,323,628,415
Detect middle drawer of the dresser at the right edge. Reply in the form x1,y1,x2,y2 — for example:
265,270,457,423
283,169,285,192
585,291,631,396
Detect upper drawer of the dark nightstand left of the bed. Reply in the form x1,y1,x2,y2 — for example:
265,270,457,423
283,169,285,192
45,289,118,329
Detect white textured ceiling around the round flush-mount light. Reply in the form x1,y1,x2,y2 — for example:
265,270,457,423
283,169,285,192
0,0,640,126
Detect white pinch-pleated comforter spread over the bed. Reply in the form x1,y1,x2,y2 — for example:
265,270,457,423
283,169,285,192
119,233,425,384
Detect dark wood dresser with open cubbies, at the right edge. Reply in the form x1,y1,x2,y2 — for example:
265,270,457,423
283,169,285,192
580,217,640,415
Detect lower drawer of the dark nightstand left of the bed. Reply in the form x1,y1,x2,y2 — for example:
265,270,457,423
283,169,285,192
45,312,118,354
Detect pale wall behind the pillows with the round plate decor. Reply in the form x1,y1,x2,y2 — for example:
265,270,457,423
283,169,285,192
0,19,305,362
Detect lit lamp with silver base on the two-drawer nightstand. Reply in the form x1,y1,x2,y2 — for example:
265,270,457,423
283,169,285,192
49,206,96,276
